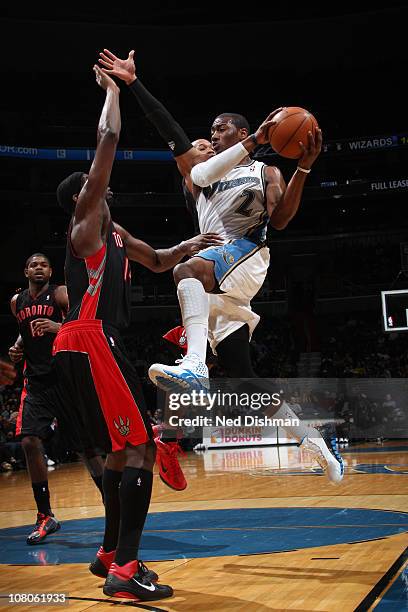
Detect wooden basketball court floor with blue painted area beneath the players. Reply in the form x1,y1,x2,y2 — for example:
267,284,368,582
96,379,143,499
0,441,408,612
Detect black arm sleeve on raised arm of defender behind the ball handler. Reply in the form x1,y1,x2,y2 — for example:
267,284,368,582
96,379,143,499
129,78,193,157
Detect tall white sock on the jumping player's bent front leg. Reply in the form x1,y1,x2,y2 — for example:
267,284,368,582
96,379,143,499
177,278,209,363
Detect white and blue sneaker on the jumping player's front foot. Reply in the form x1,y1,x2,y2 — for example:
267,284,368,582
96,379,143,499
149,353,209,393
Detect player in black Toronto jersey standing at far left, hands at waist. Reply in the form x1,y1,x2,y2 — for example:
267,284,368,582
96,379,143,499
9,253,102,544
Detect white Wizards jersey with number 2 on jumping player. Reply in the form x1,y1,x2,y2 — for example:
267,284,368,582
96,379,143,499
197,161,269,244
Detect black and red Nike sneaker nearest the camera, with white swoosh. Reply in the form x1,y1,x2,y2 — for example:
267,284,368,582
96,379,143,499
103,560,173,601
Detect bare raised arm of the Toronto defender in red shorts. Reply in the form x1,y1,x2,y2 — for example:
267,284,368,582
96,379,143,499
71,65,121,257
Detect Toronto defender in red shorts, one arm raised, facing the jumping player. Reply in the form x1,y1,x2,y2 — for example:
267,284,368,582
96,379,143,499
53,66,218,601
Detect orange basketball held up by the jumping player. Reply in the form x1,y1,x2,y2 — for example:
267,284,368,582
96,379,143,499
269,106,319,159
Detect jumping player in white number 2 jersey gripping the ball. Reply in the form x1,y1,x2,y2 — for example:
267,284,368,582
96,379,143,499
149,111,321,390
